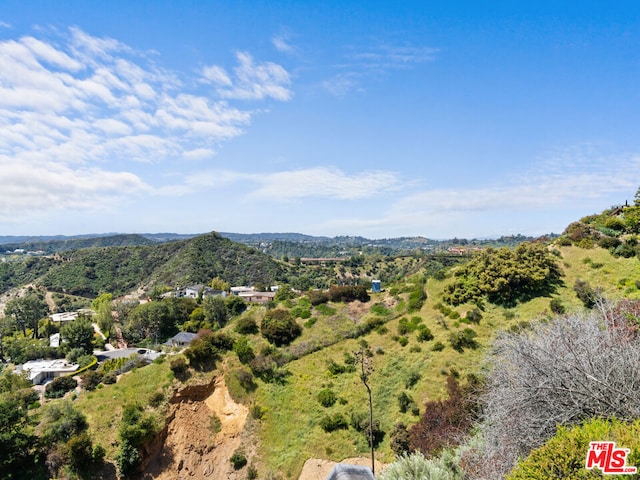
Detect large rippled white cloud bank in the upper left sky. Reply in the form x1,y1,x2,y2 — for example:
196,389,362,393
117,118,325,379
0,24,291,216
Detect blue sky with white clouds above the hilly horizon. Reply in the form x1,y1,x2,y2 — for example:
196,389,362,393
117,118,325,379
0,0,640,238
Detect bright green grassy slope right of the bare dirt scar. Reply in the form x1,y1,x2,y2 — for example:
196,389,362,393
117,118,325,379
256,247,640,478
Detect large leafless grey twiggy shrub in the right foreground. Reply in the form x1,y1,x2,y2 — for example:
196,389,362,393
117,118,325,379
473,301,640,478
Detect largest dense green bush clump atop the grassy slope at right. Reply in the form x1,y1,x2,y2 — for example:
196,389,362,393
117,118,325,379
443,243,562,305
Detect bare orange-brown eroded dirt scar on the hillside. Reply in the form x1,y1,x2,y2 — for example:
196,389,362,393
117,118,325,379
144,377,248,480
